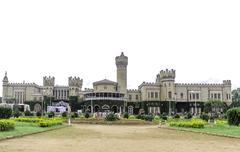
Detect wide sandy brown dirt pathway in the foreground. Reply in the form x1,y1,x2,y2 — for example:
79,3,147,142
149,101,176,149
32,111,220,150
0,124,240,152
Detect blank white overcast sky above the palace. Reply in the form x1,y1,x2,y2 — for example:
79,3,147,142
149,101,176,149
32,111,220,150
0,0,240,95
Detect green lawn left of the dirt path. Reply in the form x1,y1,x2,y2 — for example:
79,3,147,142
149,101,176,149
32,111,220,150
0,122,63,139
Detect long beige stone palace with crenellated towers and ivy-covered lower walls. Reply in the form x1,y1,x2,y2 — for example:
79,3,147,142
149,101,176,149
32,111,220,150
2,53,232,114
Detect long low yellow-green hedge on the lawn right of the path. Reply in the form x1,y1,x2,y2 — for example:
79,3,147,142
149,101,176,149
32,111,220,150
169,120,205,128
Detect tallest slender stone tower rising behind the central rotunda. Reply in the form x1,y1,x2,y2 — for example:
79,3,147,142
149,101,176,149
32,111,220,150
115,52,128,97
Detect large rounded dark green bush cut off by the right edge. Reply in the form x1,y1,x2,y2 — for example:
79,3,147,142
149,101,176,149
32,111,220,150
227,107,240,126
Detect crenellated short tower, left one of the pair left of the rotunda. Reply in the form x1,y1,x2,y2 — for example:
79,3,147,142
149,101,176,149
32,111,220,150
43,76,55,97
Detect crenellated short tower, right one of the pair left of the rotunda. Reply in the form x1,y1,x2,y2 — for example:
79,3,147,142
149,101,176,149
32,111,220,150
68,77,83,96
